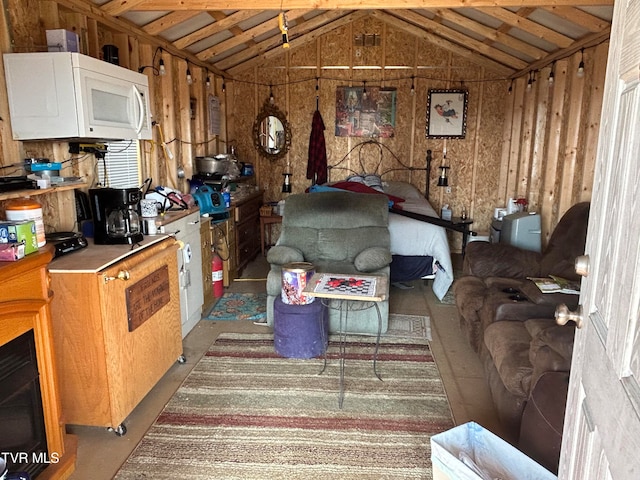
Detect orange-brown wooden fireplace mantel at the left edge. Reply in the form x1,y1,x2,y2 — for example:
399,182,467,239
0,247,77,480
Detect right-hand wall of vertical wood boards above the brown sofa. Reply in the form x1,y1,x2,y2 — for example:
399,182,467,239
498,42,609,242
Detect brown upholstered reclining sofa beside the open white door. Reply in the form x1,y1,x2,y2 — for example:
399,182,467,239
453,203,589,471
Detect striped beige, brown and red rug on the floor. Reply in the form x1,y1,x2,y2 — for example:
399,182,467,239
115,333,453,480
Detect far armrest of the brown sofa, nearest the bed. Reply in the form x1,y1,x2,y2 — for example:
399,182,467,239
462,242,542,278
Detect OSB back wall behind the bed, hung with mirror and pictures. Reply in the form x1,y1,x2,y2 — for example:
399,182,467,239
230,17,508,249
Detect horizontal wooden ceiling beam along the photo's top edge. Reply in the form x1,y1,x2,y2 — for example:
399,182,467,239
135,0,613,10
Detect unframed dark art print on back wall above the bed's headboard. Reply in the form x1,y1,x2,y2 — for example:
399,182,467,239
336,87,397,138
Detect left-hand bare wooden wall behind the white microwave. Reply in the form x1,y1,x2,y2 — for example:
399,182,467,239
0,0,226,231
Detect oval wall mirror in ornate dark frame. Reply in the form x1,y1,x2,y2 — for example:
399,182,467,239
253,99,291,161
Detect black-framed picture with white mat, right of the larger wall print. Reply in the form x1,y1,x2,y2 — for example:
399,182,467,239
427,89,469,138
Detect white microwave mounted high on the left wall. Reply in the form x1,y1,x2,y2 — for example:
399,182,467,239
4,52,152,140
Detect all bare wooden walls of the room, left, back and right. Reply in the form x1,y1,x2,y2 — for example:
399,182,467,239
0,5,607,251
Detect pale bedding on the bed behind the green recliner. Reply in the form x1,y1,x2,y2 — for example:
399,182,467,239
384,182,453,300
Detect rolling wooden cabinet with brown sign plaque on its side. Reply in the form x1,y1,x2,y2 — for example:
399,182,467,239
50,236,182,433
